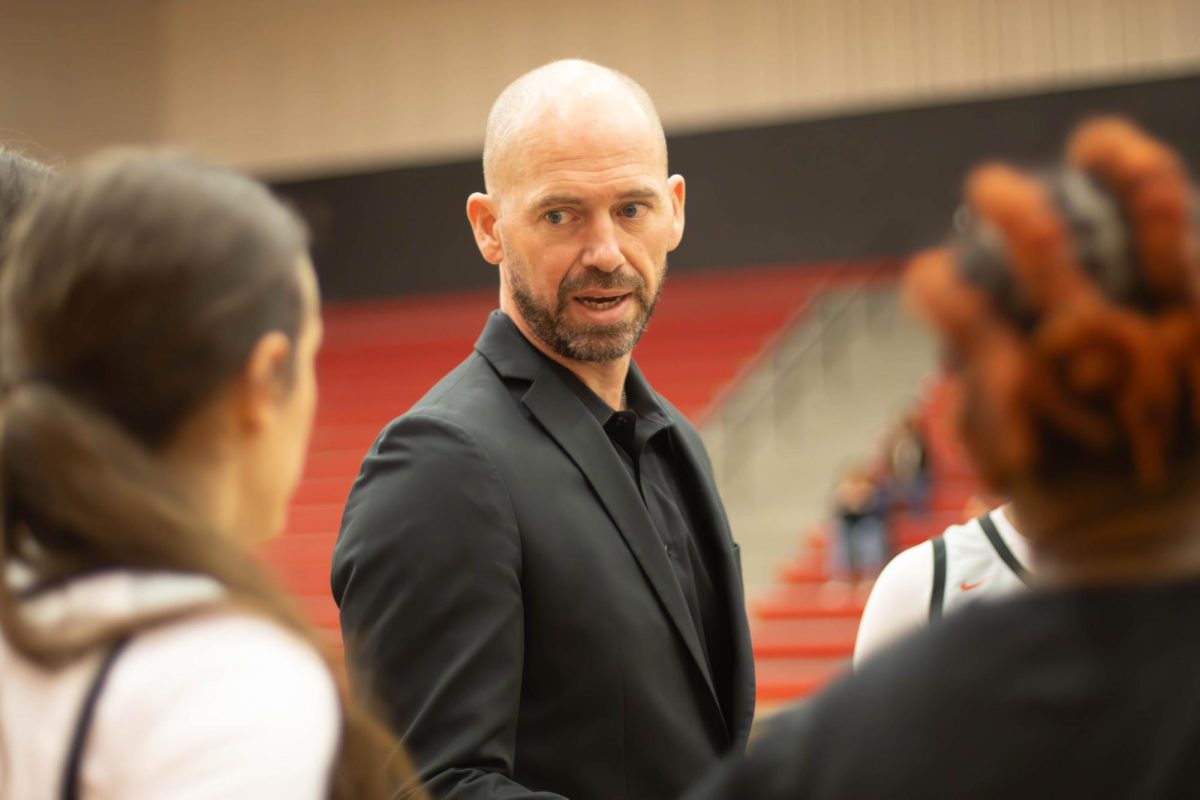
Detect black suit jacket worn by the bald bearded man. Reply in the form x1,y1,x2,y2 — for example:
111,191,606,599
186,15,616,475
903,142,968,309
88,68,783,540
332,312,755,800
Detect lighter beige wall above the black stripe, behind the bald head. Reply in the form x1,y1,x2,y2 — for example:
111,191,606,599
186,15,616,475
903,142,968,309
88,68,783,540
142,0,1200,174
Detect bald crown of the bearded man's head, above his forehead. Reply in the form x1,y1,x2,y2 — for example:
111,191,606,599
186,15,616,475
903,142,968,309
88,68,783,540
484,59,667,194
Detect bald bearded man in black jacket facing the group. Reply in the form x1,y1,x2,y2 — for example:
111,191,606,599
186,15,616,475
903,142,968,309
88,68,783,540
332,61,754,800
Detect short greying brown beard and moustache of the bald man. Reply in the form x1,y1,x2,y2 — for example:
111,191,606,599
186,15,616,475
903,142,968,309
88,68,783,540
508,257,666,362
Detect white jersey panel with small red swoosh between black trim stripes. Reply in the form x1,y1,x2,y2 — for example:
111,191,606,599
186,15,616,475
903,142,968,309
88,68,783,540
929,509,1030,620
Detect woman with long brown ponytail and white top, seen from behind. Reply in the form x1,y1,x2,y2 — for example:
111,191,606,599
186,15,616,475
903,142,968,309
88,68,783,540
0,154,422,800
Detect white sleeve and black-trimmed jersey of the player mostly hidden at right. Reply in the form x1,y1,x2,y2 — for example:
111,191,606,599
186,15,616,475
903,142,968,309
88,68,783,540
854,507,1031,666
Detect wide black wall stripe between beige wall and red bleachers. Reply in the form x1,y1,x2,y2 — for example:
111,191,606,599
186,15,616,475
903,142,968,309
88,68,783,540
275,73,1200,297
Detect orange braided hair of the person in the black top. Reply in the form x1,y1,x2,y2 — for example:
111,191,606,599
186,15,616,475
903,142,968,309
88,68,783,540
905,118,1200,485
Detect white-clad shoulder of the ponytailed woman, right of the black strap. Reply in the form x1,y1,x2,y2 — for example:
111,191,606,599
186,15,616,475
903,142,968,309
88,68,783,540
89,610,341,798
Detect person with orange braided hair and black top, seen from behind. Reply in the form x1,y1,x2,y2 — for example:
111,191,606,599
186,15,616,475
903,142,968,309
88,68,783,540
686,118,1200,800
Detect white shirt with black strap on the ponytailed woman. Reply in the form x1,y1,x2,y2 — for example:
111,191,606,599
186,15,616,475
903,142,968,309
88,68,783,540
0,573,341,800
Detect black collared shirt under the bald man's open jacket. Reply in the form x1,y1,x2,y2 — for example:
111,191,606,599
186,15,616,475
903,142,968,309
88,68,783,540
547,359,733,718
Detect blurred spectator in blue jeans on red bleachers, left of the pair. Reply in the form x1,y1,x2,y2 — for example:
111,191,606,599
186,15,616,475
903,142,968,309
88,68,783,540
821,463,888,606
